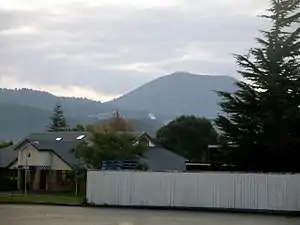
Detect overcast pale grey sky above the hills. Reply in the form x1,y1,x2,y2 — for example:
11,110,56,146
0,0,269,101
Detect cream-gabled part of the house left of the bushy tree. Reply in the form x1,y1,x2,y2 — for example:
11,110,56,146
0,132,89,191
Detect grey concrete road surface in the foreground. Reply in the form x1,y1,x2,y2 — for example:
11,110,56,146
0,205,300,225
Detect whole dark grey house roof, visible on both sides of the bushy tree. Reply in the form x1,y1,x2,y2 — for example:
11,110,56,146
0,132,187,171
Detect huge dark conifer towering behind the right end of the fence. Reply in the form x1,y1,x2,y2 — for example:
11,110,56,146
216,0,300,171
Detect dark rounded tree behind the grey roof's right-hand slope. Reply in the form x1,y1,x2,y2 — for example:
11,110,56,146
157,116,217,160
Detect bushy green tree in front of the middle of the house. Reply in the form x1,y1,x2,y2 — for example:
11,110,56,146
74,126,146,169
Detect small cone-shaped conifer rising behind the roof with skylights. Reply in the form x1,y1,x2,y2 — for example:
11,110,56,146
48,103,70,132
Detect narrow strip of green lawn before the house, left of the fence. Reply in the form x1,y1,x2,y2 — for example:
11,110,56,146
0,194,83,203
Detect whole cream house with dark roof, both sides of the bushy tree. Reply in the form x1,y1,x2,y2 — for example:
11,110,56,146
0,132,186,191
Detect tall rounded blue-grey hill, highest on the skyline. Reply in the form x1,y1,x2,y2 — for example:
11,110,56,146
105,72,236,118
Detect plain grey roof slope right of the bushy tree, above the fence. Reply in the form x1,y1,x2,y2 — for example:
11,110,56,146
142,147,187,171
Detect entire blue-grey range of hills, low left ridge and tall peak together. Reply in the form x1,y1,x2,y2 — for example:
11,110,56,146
0,72,236,140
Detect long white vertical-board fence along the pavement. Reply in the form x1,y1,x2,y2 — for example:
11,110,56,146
86,171,300,211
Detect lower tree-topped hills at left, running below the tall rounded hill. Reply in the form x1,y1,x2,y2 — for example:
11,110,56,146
0,89,162,141
